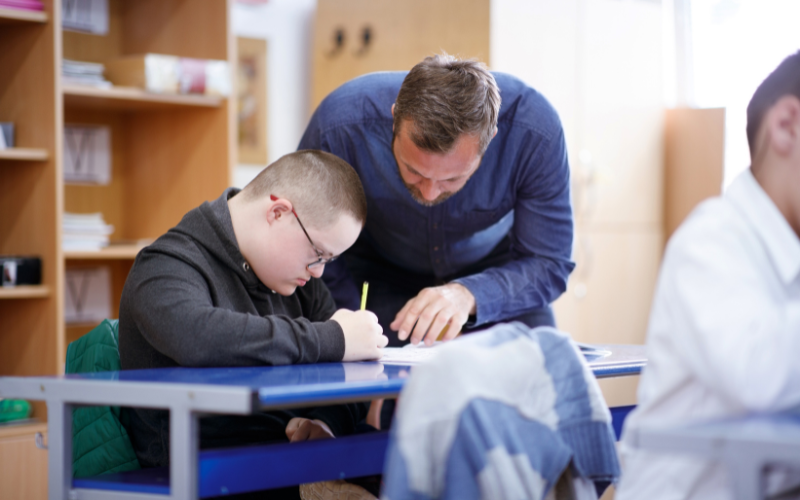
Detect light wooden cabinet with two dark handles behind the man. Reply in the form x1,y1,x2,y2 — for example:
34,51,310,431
311,0,489,110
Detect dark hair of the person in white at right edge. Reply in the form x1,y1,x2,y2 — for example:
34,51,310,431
747,51,800,159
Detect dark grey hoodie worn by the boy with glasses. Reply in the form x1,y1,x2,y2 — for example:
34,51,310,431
119,189,366,467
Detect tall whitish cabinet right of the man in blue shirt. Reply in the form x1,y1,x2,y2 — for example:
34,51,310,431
491,0,668,352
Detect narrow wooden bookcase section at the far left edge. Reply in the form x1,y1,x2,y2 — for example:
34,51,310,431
0,0,59,406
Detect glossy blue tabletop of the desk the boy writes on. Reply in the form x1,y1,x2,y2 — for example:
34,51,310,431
0,345,646,411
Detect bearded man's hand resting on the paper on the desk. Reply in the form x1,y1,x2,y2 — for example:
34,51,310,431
389,283,475,345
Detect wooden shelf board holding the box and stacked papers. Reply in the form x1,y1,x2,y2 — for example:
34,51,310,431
62,85,225,111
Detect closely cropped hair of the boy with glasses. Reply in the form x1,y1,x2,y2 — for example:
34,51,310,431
241,149,367,228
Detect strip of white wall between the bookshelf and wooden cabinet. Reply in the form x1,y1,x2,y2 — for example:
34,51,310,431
232,0,317,187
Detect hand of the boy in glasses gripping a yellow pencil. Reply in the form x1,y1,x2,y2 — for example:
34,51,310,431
331,309,389,361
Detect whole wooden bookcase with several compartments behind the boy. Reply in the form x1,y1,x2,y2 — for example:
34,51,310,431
0,0,236,499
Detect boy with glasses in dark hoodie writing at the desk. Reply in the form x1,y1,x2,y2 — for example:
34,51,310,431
119,151,388,498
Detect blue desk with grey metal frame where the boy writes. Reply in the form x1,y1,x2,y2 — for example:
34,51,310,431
0,345,646,500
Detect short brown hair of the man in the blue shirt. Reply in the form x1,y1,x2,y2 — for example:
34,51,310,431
394,54,500,154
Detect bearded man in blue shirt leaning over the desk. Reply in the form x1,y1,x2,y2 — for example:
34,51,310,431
299,55,574,345
